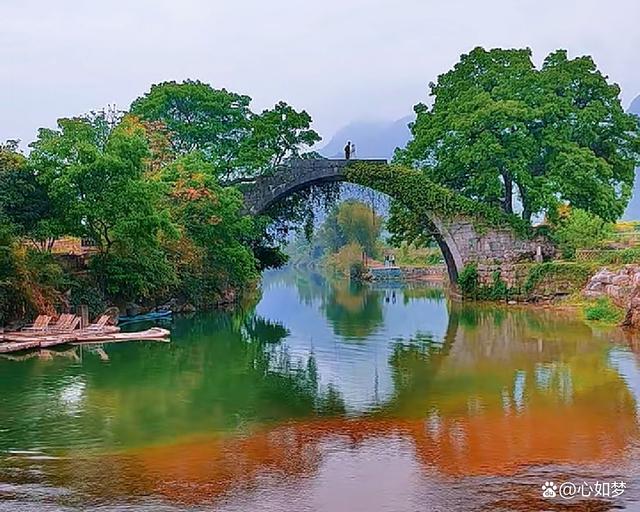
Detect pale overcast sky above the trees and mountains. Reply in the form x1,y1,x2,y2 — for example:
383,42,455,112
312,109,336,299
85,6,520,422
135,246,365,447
0,0,640,148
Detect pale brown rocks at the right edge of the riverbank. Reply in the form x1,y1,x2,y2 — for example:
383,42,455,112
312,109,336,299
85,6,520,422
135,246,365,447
584,265,640,328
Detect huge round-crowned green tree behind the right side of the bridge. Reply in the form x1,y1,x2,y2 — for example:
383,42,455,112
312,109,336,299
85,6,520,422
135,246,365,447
396,48,640,220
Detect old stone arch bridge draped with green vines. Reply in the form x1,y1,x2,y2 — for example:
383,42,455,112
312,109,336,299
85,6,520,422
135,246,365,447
244,159,553,286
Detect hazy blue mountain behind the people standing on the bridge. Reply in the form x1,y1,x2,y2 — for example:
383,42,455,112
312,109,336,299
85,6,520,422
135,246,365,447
318,116,414,160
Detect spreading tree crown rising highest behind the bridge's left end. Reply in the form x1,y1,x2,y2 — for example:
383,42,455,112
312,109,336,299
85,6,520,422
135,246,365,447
131,80,320,181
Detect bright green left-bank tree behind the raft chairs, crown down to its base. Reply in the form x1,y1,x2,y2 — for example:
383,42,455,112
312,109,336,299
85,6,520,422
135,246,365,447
29,114,174,299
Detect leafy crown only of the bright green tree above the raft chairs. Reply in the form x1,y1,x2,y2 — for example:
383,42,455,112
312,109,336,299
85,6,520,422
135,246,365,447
30,118,168,253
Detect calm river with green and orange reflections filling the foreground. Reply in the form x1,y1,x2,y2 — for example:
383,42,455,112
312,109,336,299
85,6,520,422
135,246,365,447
0,269,640,512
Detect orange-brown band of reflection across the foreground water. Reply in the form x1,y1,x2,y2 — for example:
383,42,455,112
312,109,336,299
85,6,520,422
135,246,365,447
104,396,637,503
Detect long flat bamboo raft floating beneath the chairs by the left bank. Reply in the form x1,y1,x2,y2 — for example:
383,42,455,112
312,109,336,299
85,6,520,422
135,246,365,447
0,327,171,354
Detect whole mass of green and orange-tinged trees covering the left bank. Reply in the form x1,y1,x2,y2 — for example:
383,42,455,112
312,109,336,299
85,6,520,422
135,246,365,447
0,76,319,317
